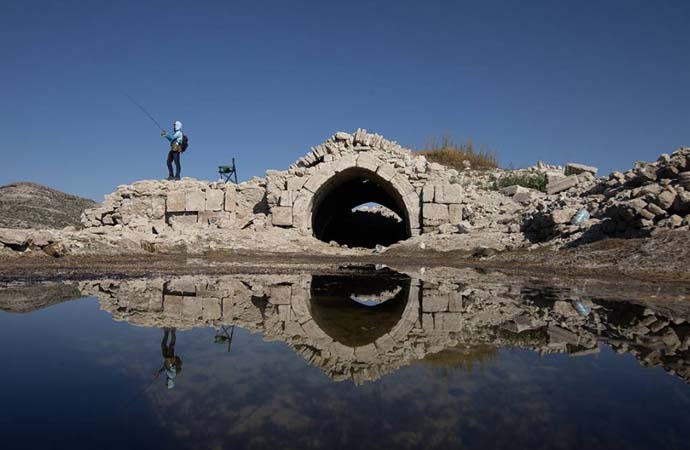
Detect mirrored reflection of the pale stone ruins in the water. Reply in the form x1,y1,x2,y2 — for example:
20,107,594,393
81,269,690,383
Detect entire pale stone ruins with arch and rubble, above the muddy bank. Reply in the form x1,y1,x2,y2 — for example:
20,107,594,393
0,129,690,256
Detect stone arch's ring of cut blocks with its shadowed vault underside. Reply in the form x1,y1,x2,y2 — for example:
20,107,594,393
293,154,420,237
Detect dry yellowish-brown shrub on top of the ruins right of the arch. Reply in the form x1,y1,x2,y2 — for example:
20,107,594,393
417,136,498,170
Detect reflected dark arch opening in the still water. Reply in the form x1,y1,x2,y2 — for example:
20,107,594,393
310,271,410,347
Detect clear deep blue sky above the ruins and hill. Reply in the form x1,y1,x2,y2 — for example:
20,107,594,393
0,0,690,200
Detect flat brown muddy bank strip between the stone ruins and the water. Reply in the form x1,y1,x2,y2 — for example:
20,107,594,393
0,231,690,283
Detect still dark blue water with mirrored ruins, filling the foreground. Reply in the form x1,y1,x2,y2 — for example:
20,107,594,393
0,269,690,449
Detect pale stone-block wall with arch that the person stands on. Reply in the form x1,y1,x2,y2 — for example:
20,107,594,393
82,129,484,236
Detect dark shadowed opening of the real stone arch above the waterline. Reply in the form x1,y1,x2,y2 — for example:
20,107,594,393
312,167,410,248
